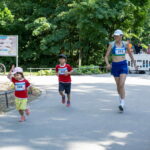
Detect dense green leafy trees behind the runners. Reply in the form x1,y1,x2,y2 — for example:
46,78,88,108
0,0,150,67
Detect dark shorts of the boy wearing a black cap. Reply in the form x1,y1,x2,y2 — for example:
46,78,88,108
59,82,71,94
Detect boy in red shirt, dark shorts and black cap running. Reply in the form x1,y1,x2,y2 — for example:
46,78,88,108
56,54,73,107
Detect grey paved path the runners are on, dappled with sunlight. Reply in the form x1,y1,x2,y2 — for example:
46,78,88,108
0,75,150,150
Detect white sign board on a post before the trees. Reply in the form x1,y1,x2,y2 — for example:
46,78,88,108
0,35,18,56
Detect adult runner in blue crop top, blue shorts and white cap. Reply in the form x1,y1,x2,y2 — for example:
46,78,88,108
105,30,137,112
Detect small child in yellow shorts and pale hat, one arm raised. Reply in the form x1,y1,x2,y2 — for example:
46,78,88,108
7,65,30,122
